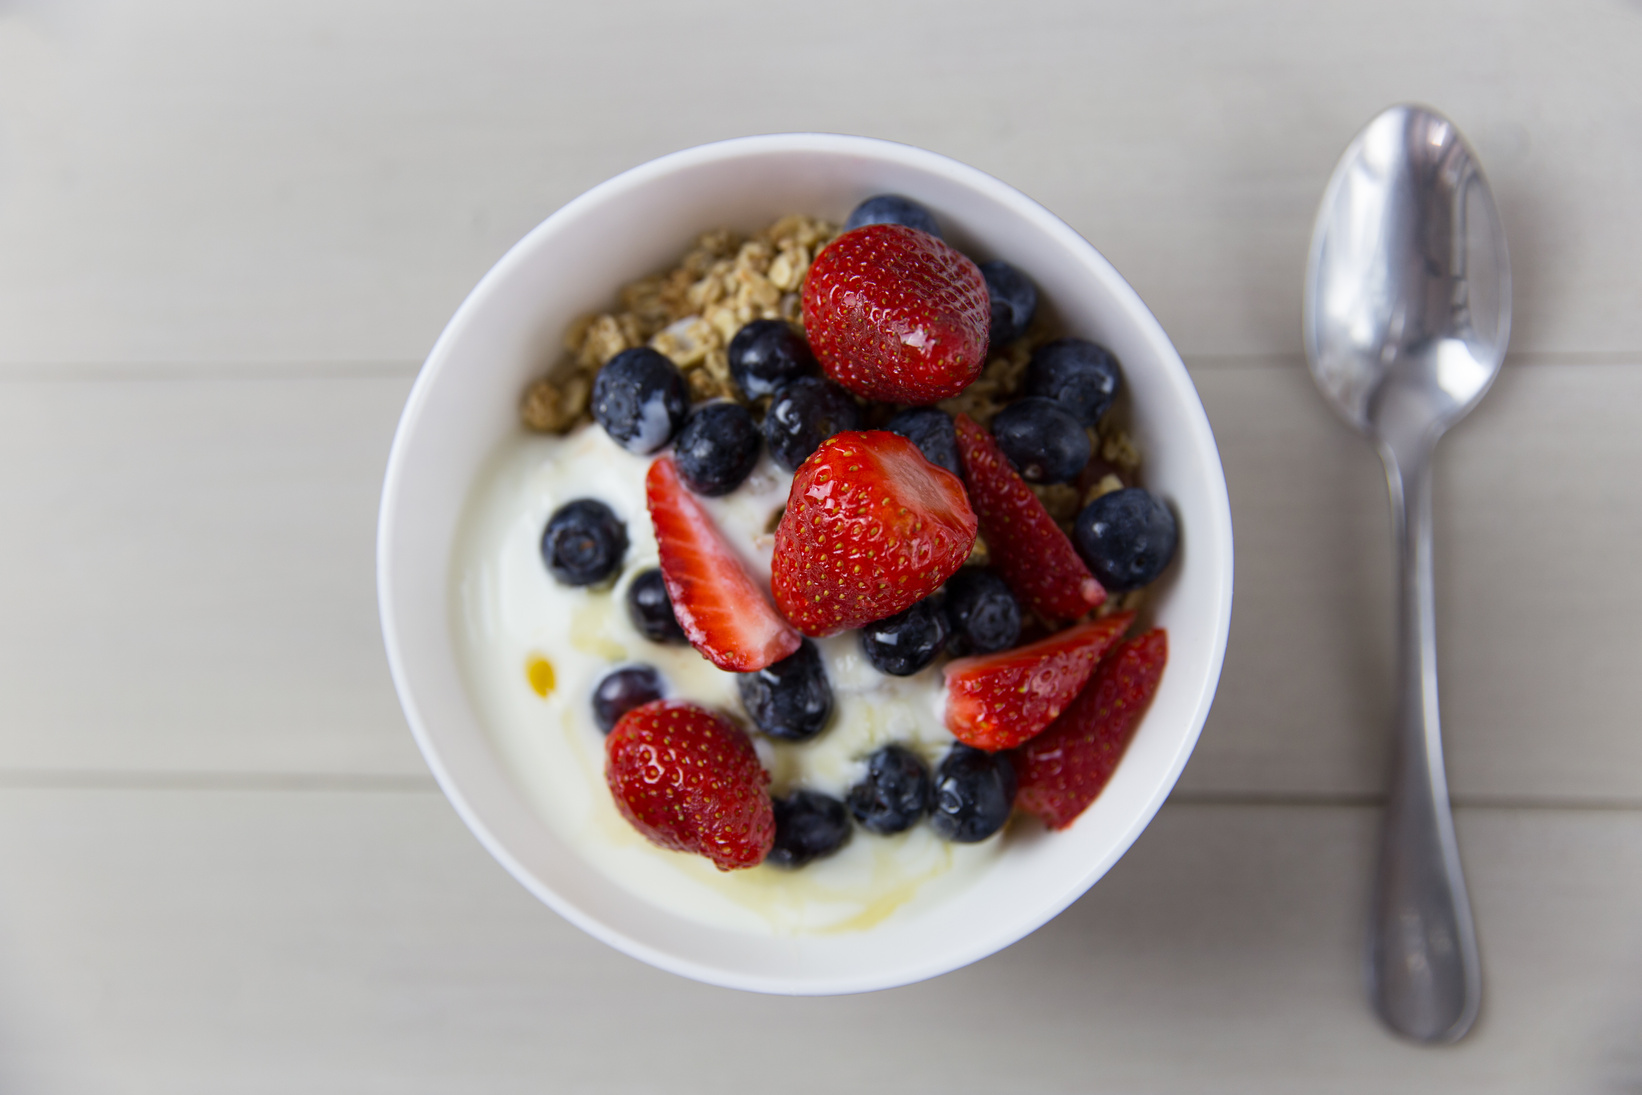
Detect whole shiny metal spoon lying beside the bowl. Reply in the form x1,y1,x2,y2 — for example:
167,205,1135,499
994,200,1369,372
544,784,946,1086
1304,105,1511,1042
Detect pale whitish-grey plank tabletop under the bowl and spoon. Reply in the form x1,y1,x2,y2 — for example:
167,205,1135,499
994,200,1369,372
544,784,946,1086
0,0,1642,1095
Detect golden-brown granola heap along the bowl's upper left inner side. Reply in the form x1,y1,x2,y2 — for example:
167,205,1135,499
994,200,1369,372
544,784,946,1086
521,213,839,433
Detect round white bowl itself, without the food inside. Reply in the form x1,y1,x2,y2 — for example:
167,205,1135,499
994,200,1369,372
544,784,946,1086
378,133,1232,993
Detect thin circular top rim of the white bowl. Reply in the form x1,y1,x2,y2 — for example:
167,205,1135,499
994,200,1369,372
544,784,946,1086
376,131,1235,995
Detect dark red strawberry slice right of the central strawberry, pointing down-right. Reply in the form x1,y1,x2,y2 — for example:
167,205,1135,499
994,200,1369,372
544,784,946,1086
957,414,1107,619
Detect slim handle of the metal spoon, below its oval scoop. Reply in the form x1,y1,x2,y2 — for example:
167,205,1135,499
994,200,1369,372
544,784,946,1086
1368,438,1483,1042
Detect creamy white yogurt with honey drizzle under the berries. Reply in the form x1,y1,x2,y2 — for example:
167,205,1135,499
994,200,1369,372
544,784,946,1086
453,427,1002,934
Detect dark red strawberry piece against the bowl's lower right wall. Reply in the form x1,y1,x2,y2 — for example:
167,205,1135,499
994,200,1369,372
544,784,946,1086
1013,629,1169,829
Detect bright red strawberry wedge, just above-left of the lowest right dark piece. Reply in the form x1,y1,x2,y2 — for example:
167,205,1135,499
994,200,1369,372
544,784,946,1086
946,612,1135,752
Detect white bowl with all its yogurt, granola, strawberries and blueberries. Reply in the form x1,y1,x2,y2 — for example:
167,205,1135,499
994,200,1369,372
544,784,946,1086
378,135,1232,995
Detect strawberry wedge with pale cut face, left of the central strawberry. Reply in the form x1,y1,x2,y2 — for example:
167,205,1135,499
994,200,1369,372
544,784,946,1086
644,456,801,673
